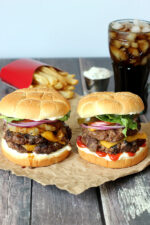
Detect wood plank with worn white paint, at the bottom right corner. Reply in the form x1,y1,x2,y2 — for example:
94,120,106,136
80,59,150,225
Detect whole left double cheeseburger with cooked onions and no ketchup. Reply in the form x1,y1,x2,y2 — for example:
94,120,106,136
0,88,71,167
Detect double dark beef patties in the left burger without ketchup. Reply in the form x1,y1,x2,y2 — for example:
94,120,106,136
4,123,72,154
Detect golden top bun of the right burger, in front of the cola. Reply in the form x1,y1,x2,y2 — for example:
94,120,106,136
77,92,144,118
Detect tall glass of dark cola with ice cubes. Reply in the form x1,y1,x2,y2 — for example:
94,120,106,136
109,19,150,111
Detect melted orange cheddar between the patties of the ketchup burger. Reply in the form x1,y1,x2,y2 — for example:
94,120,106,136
100,132,147,148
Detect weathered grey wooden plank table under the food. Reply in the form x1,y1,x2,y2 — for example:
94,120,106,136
0,58,150,225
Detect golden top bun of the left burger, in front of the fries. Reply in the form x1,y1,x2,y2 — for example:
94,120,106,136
0,88,70,120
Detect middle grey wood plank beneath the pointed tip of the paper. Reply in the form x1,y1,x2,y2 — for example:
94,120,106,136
31,59,102,225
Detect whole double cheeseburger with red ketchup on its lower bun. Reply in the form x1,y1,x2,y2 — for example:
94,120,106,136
77,92,148,168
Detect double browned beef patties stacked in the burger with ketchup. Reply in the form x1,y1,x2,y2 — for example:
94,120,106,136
81,121,145,154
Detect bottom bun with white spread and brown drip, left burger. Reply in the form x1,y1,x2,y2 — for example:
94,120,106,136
1,139,71,167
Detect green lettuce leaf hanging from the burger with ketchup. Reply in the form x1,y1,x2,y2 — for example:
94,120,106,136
96,114,138,137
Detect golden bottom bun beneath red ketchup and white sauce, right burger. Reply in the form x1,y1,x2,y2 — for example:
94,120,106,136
78,146,148,169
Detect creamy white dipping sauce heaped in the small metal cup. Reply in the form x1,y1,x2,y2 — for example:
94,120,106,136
83,67,112,80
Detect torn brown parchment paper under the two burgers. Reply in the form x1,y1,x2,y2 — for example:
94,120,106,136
0,95,150,195
